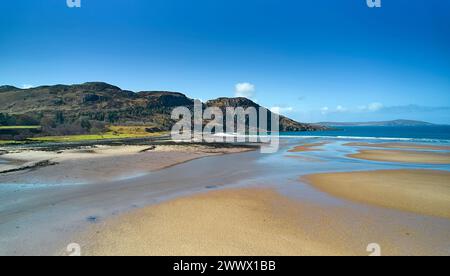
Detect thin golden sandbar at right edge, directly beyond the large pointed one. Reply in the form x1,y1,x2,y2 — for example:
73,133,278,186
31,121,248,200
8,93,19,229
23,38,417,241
348,150,450,165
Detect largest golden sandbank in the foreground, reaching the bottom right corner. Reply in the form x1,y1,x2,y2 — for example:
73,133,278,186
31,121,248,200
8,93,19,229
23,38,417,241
78,185,450,256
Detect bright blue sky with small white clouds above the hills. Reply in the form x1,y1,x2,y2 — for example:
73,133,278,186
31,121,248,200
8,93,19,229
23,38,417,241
0,0,450,123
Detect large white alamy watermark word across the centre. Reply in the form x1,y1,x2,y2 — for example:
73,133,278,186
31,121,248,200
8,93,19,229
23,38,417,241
171,100,280,153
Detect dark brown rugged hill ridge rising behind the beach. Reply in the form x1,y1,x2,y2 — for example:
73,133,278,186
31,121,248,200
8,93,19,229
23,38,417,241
0,82,323,131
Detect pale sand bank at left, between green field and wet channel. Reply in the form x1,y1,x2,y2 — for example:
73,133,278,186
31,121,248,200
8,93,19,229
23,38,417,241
0,144,252,184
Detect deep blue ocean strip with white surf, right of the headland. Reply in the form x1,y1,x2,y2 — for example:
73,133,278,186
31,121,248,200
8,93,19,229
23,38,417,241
281,125,450,143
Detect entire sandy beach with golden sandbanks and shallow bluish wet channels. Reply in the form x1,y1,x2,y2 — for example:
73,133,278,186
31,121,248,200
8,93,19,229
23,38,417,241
0,139,450,256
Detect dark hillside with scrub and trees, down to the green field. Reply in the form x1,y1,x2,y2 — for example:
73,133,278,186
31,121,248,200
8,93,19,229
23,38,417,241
0,82,324,139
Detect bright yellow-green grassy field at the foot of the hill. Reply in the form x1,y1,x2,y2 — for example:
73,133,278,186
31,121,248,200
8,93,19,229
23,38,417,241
30,126,168,142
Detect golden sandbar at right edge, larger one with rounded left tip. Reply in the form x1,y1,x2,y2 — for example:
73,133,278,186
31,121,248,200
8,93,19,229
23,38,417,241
304,170,450,219
